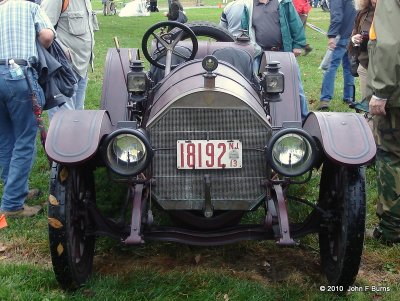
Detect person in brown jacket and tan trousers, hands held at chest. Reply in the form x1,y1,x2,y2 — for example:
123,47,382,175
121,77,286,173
348,0,376,100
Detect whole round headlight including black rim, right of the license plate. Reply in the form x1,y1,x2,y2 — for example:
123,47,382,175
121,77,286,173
267,129,316,177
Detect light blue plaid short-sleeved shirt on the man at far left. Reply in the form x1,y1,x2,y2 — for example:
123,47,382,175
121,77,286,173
0,0,54,60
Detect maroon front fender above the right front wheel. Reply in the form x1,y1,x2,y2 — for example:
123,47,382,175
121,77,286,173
303,112,376,165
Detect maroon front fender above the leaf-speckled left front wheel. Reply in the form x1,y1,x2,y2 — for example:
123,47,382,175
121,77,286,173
45,110,112,164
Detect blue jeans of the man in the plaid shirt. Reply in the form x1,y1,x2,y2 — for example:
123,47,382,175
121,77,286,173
0,65,44,211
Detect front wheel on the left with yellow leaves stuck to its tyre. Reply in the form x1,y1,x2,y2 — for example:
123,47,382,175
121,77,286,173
48,163,95,289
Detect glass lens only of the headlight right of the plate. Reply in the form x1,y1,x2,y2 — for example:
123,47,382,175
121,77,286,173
272,133,312,176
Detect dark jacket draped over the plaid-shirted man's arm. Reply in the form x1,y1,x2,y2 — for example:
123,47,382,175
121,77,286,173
35,40,77,110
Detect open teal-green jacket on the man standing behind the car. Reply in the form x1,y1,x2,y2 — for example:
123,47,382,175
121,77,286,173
244,0,306,55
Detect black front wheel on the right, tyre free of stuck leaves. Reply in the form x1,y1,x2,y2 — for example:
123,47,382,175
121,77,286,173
319,162,365,292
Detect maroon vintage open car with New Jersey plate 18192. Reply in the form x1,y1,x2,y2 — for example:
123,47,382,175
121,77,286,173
45,22,376,290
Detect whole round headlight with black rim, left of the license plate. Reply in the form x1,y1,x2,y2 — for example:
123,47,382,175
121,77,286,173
103,129,153,176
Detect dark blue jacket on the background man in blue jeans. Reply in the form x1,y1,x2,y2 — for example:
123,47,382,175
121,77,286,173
328,0,356,38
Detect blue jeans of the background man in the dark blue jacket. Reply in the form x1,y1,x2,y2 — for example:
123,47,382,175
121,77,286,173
320,38,354,101
